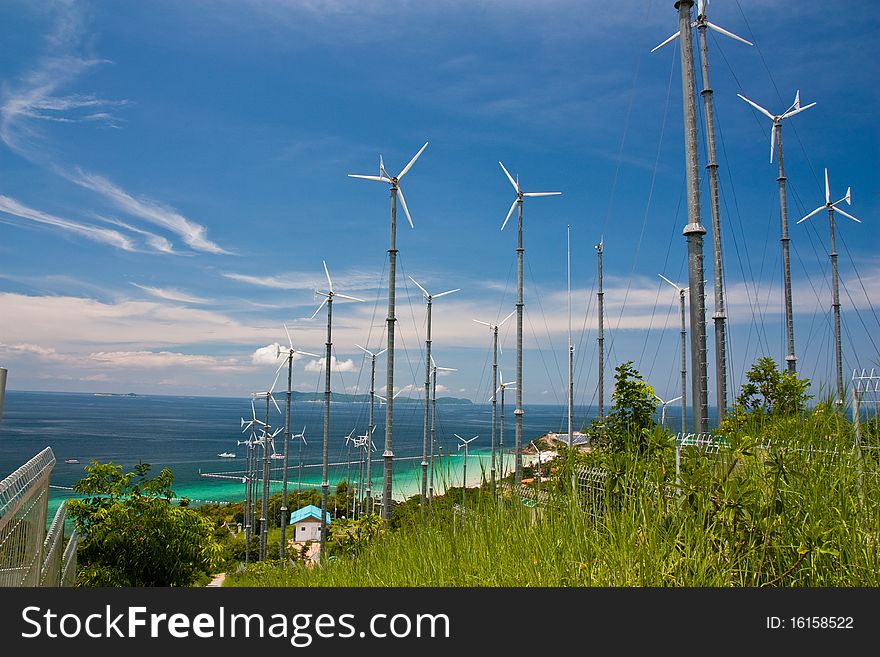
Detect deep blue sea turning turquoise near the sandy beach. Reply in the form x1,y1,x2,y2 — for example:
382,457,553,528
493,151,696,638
0,390,616,518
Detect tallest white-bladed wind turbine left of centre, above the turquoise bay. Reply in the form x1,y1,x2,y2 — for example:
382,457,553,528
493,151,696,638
348,142,428,520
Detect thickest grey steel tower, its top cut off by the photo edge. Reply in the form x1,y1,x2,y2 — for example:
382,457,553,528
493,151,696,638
656,0,709,433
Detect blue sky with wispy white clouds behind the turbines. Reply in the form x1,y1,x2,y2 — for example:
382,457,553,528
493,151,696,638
0,0,880,404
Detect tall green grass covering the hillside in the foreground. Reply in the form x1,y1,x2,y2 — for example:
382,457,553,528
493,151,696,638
224,411,880,587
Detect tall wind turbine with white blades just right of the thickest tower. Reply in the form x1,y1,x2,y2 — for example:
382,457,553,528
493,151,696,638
652,0,754,421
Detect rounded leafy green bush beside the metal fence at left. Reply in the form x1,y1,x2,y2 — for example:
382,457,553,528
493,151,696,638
68,460,222,586
